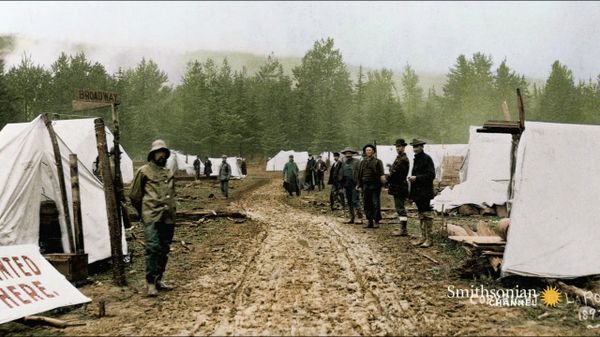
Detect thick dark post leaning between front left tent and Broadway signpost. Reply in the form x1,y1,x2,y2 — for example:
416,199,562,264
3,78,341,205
94,118,127,286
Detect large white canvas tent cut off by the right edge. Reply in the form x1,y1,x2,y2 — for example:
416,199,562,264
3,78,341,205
502,122,600,278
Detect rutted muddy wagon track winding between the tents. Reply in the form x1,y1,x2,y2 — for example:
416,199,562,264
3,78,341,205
192,180,423,335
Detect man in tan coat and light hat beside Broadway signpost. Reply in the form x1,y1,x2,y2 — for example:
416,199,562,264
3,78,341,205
129,139,176,296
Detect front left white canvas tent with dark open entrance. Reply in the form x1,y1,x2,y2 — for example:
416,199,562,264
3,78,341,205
0,117,127,263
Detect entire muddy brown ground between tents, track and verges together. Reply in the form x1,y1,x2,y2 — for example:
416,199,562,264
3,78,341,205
0,167,597,336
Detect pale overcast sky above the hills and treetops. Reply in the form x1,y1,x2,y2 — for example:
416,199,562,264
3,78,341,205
0,2,600,79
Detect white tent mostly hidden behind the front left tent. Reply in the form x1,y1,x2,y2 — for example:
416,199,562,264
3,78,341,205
2,118,134,184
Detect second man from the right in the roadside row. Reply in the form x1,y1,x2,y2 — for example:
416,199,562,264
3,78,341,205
388,138,410,236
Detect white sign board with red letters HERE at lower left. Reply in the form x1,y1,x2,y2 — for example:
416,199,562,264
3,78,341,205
0,245,91,324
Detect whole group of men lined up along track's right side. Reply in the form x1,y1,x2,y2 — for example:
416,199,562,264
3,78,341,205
283,139,435,248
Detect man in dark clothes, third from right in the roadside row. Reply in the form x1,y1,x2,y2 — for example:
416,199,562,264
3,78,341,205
357,144,385,228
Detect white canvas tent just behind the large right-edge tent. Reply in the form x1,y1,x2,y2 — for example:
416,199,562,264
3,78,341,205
432,126,512,212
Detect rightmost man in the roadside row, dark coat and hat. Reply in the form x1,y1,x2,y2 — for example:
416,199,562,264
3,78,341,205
408,139,435,248
